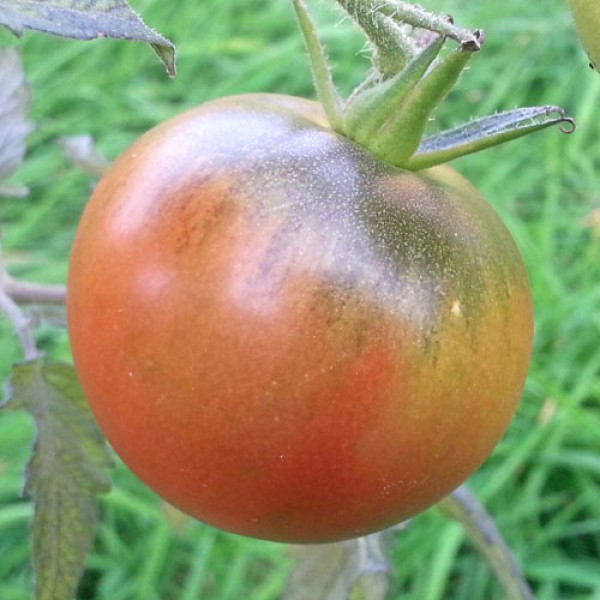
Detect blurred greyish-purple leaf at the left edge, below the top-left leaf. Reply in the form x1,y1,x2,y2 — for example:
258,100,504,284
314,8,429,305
0,48,33,196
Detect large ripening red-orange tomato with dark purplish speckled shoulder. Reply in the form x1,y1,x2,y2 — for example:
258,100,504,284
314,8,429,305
67,95,532,543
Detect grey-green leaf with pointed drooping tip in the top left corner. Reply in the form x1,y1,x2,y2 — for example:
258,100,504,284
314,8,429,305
0,0,175,76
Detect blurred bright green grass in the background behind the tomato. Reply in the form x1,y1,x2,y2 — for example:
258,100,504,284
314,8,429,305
0,0,600,600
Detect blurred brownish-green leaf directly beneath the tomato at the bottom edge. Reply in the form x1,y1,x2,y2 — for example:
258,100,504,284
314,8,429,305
284,533,388,600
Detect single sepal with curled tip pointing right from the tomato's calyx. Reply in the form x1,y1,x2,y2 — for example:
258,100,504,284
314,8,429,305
407,106,575,170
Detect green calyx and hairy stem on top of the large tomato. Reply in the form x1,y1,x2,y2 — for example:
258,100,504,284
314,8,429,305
292,0,575,170
